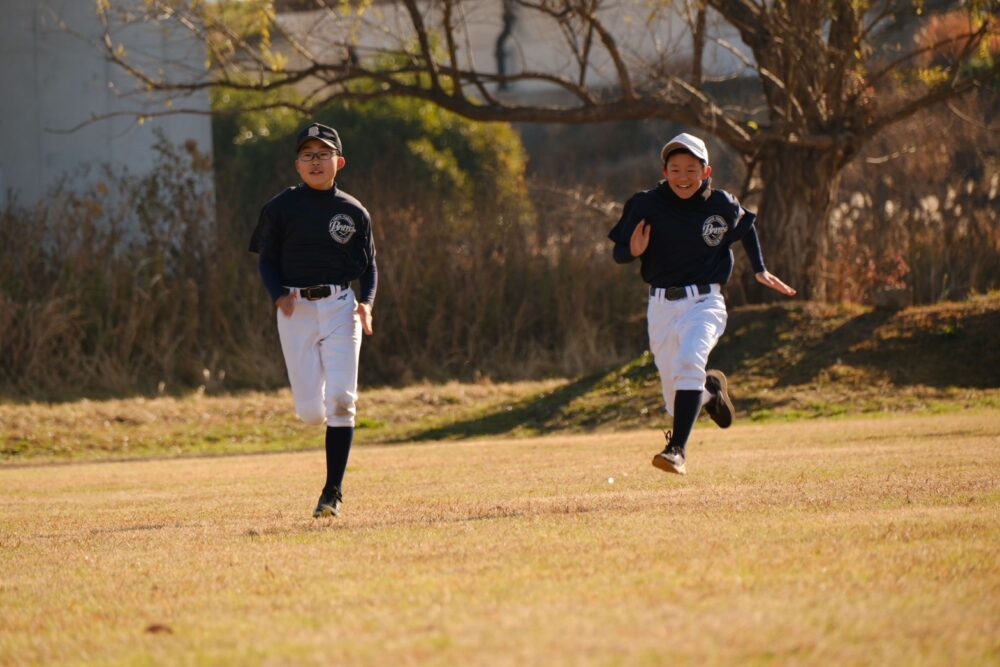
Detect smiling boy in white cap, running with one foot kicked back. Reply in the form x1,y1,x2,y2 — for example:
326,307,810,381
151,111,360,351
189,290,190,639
608,133,795,475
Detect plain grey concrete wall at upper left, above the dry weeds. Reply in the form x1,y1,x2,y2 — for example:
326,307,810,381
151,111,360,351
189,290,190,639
0,0,212,205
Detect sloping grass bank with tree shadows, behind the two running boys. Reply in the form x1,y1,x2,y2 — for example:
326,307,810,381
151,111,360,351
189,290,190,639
0,293,1000,464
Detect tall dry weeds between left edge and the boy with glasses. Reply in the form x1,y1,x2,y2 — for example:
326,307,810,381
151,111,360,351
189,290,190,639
0,135,274,398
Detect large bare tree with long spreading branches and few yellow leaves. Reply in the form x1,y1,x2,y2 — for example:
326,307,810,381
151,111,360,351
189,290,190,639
98,0,998,298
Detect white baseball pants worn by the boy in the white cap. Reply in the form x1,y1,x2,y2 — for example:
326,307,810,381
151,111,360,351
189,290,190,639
646,284,728,415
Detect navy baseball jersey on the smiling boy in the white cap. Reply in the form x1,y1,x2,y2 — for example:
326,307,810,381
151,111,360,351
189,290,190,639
608,179,764,287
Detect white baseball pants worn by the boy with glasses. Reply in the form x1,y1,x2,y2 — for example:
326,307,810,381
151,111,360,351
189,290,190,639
277,287,361,426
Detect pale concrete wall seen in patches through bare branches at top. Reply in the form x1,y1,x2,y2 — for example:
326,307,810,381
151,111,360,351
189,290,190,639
279,0,750,102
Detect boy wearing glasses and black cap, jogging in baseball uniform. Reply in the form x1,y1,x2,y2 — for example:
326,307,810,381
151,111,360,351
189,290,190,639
250,123,378,518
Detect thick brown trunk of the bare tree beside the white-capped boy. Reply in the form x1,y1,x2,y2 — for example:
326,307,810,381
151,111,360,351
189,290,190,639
757,144,843,301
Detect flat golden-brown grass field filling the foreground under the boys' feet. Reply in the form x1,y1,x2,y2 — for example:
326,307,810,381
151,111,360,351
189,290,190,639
0,409,1000,665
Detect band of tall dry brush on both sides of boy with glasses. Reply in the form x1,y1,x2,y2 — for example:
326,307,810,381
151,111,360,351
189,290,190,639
0,126,642,399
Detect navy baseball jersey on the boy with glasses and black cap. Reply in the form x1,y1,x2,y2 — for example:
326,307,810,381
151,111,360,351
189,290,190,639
250,184,377,304
